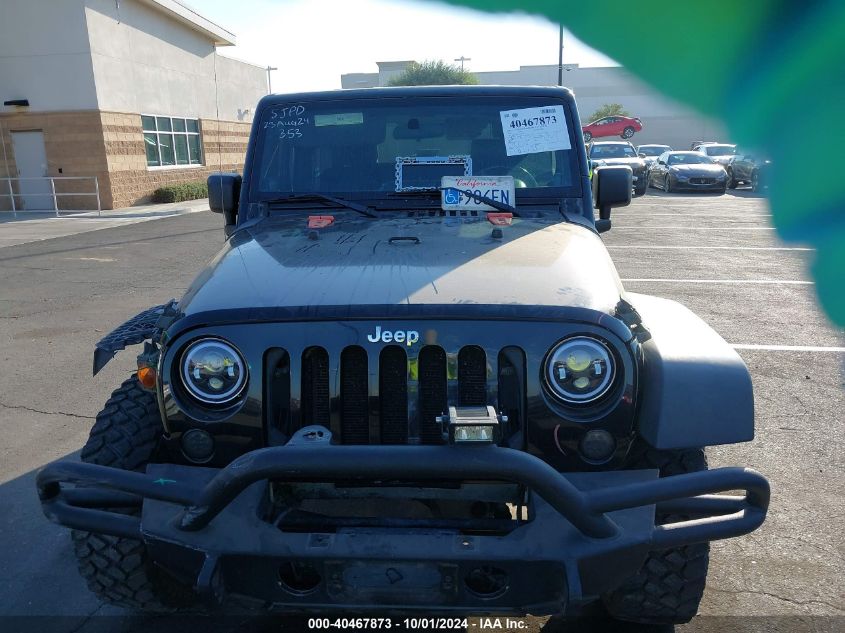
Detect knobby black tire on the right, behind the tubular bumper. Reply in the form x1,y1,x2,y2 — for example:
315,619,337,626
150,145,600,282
602,448,710,624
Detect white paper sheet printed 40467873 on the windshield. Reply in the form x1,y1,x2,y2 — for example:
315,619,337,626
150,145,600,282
499,105,572,156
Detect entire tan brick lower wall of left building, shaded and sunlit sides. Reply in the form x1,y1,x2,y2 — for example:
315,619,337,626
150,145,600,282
0,111,250,210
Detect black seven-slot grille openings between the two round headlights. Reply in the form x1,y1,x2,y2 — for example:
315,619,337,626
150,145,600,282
288,345,525,444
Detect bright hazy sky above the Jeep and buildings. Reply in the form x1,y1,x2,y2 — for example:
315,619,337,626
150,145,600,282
195,0,616,92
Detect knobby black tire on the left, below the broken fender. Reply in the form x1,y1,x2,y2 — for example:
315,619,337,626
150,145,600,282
72,375,194,612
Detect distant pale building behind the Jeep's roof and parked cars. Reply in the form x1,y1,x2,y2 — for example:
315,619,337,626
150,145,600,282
341,62,727,149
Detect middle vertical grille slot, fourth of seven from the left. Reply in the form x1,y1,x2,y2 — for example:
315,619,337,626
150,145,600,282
379,345,408,444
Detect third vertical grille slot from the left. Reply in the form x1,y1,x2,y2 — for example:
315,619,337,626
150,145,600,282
340,346,370,444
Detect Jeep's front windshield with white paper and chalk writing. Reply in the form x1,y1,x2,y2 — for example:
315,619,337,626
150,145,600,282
251,97,580,200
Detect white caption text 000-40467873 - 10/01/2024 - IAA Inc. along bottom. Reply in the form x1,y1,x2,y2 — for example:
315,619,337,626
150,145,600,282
308,617,528,631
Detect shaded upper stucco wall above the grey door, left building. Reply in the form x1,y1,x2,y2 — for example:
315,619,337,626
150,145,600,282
0,0,97,112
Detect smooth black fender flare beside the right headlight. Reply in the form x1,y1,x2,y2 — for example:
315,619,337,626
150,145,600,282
627,293,754,449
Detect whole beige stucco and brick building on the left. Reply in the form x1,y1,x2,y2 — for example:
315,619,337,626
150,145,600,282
0,0,267,210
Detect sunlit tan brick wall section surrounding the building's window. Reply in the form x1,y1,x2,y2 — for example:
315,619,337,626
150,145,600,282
101,112,250,208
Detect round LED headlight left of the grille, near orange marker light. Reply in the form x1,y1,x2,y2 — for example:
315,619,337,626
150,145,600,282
182,339,247,404
